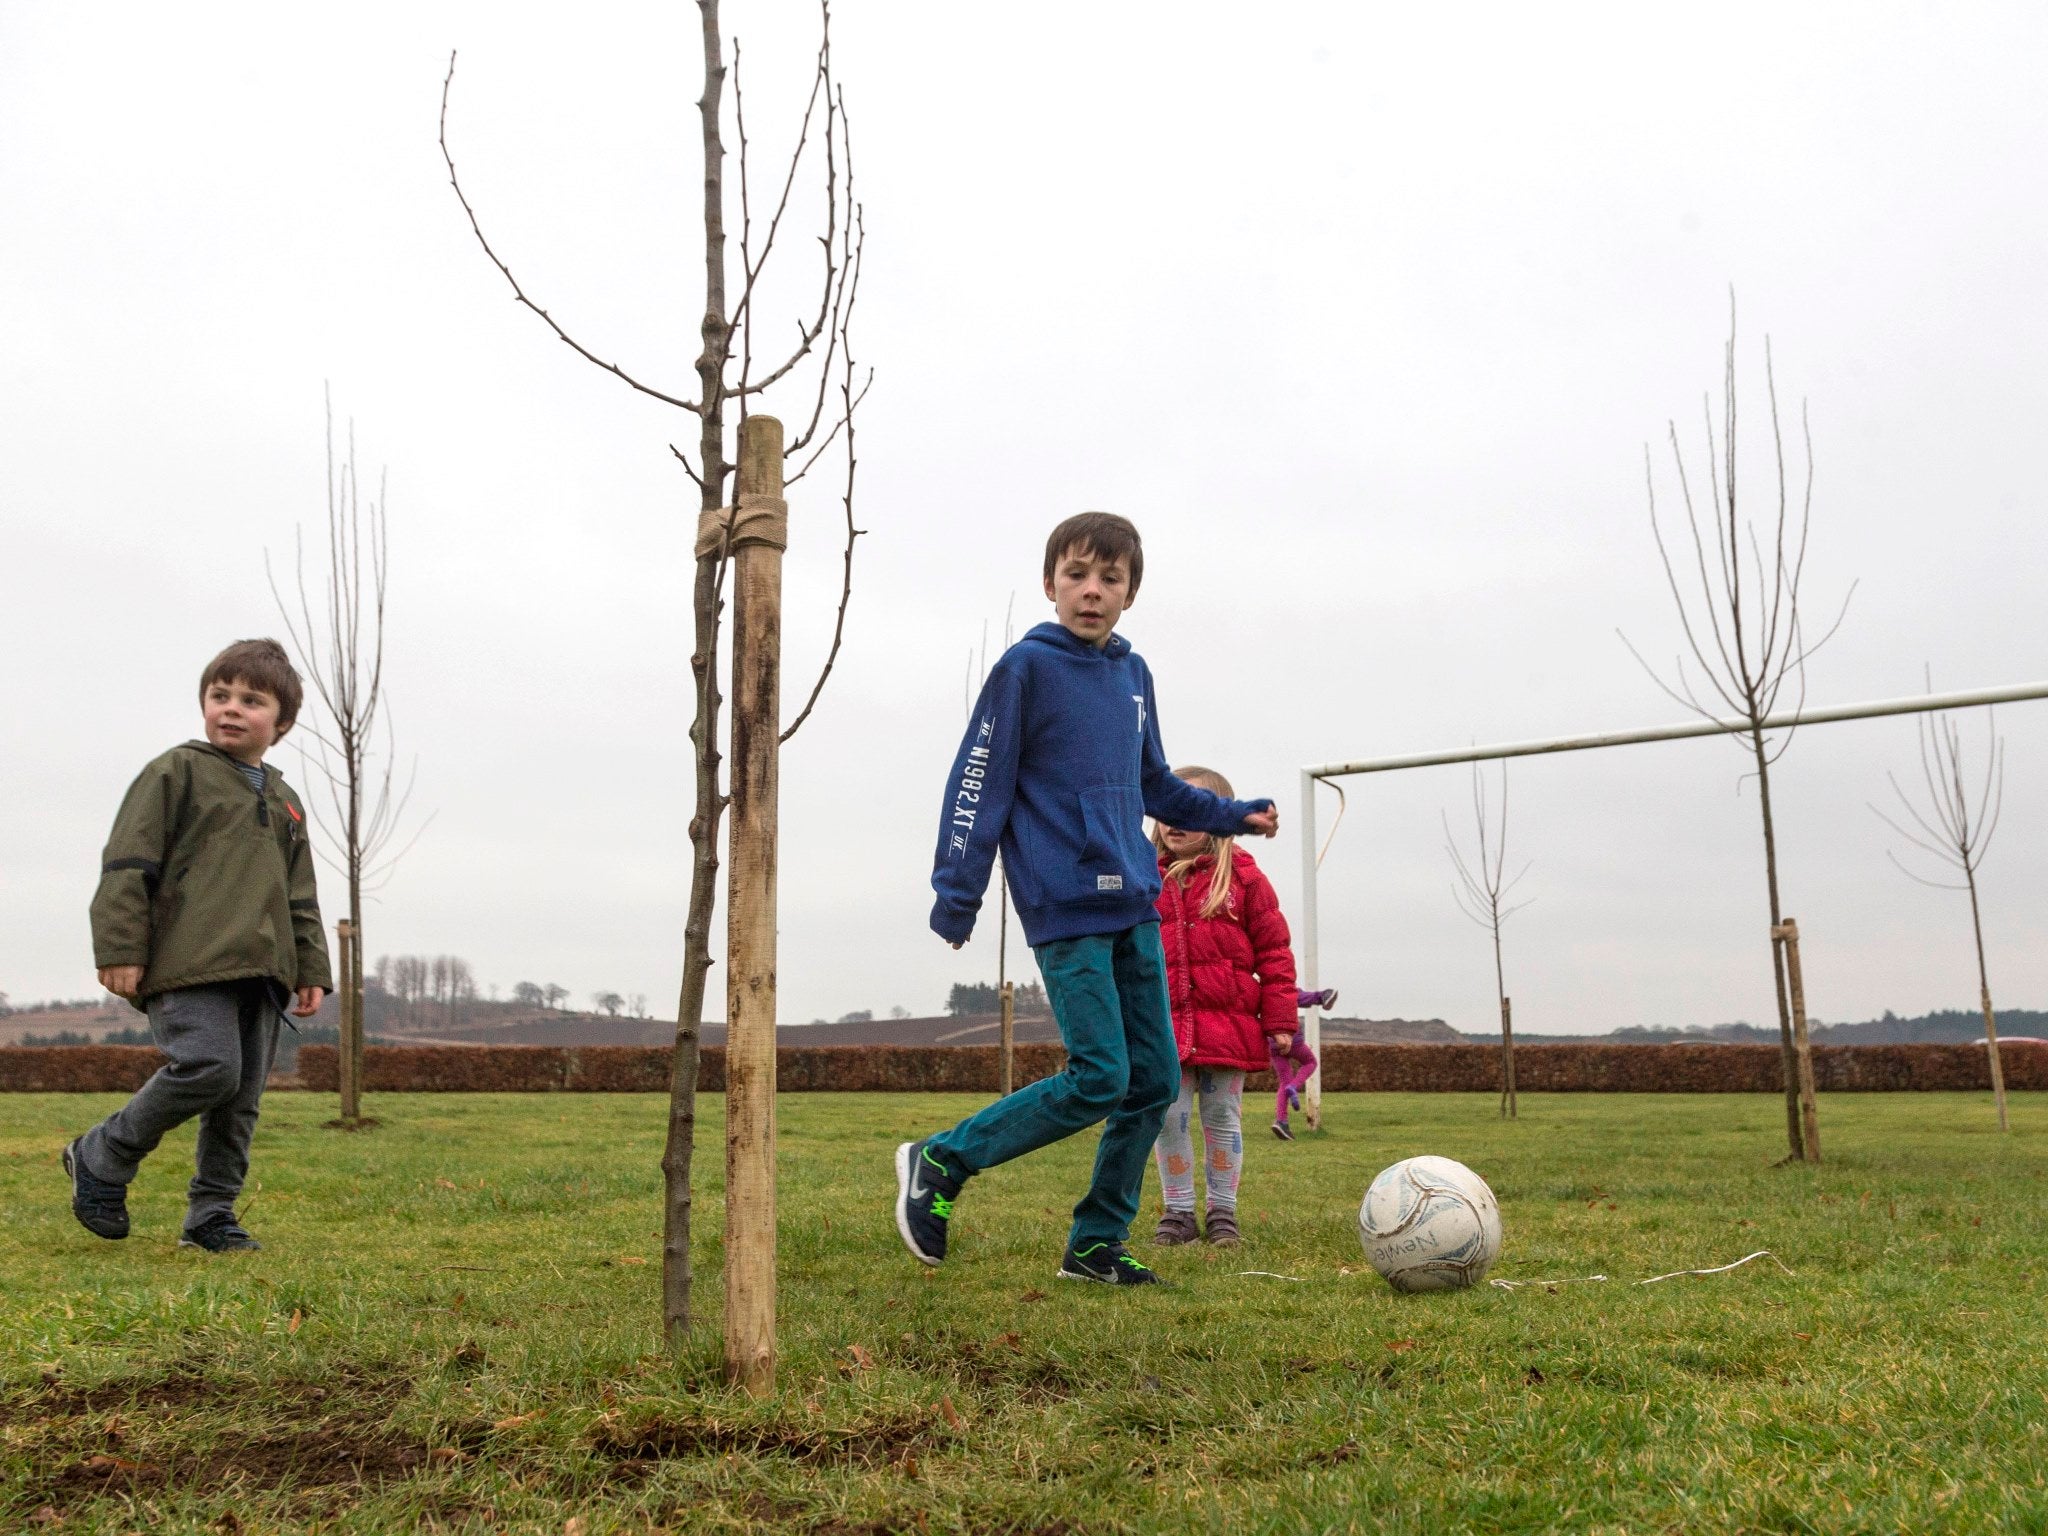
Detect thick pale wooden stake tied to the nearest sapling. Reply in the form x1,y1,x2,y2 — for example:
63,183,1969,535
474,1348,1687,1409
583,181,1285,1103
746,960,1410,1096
725,416,786,1397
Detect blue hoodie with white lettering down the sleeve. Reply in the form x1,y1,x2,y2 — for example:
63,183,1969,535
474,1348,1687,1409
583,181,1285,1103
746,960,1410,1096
932,625,1272,948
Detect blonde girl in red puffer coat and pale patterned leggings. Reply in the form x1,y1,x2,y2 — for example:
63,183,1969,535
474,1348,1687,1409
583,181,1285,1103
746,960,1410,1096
1153,768,1294,1245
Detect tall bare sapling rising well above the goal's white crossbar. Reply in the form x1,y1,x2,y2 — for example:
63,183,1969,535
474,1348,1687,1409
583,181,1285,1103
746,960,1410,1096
1616,307,1855,1163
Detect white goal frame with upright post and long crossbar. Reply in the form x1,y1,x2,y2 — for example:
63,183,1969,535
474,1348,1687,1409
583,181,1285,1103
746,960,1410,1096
1300,682,2048,1114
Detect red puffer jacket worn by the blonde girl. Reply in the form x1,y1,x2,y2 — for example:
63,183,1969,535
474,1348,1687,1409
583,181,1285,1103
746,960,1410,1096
1159,848,1294,1071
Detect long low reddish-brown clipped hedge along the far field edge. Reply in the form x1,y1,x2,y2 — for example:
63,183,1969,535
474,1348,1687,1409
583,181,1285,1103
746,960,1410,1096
0,1042,2048,1094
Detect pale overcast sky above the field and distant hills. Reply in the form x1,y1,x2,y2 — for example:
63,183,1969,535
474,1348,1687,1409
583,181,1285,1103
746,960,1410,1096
0,0,2048,1032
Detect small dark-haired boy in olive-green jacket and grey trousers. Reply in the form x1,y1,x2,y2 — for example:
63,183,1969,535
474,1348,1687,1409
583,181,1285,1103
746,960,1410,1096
63,639,332,1253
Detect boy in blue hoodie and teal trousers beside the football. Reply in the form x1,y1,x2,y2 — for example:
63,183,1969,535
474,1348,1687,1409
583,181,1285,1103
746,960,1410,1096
897,512,1280,1286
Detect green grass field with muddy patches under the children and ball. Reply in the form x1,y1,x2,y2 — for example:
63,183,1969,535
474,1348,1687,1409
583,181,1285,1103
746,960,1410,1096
0,1094,2048,1536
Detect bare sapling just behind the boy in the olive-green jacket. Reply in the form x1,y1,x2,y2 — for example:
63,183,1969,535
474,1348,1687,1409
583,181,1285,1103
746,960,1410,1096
264,397,424,1128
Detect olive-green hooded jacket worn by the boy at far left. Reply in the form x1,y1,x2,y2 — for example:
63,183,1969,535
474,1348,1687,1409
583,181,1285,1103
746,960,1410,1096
92,741,334,1001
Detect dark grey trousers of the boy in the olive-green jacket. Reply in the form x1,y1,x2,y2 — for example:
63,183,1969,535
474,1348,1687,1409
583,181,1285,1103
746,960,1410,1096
78,977,281,1231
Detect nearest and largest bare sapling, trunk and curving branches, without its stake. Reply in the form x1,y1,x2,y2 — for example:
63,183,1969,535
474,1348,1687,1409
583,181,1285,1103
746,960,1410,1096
440,0,872,1350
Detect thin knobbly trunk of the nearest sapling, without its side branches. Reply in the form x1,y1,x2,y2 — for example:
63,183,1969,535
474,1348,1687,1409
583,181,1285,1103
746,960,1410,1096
662,0,731,1352
